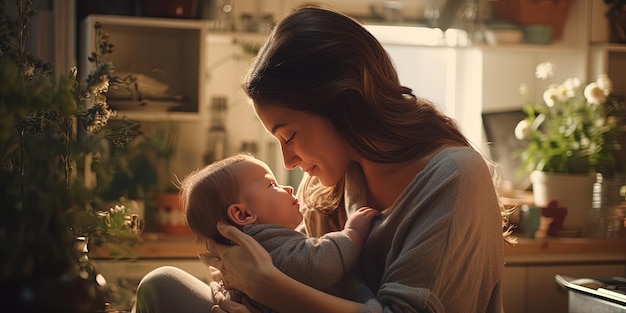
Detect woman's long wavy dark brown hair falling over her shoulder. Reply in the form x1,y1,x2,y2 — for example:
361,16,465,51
243,6,512,244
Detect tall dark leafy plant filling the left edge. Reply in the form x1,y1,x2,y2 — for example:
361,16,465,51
0,0,141,312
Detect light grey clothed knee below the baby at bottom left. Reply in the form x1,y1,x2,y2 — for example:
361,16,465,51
132,266,215,313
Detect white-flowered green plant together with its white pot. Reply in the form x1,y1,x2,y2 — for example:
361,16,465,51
515,62,624,231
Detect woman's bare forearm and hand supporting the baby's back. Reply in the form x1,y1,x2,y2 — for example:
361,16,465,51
209,223,363,313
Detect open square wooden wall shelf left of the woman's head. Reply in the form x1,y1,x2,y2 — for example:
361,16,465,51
78,15,207,121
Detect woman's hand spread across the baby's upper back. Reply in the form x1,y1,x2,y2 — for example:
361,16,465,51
205,222,278,298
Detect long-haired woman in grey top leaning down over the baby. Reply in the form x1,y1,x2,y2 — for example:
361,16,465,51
132,7,508,312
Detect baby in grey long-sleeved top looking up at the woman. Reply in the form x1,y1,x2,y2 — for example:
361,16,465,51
180,154,380,312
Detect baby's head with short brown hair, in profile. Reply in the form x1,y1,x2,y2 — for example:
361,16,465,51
180,154,302,240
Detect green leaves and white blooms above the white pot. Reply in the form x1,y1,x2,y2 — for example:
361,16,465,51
515,62,624,176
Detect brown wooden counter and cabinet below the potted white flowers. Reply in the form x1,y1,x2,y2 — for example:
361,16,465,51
503,238,626,313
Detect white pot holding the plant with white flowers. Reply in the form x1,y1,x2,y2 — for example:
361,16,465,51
530,171,596,235
